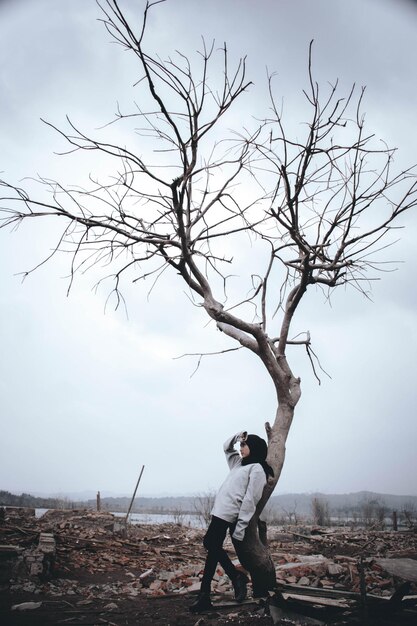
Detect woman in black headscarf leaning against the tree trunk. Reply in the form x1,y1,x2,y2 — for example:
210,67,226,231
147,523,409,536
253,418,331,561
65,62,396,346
190,432,273,613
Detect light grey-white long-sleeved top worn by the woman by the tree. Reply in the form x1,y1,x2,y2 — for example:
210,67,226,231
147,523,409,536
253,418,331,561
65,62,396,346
211,433,266,541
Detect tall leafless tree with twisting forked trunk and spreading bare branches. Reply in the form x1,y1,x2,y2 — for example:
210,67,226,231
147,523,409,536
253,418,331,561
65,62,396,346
1,0,417,595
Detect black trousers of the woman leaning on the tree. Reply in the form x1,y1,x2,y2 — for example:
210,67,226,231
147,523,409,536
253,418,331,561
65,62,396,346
201,515,238,593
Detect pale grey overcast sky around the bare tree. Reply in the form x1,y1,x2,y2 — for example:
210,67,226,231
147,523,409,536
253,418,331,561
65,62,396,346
0,0,417,495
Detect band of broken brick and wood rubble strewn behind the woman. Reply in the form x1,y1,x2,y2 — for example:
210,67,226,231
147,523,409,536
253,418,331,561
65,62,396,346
0,510,417,620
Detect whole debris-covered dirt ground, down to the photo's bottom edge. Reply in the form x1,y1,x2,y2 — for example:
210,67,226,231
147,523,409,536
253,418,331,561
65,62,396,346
0,510,417,626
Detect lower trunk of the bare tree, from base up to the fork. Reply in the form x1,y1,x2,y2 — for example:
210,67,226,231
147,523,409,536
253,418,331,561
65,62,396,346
233,396,299,597
